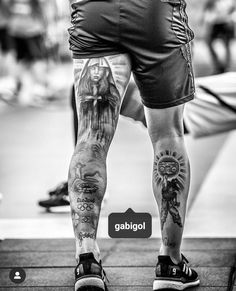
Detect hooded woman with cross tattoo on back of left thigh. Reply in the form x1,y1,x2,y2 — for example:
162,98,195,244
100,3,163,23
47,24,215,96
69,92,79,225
78,58,121,134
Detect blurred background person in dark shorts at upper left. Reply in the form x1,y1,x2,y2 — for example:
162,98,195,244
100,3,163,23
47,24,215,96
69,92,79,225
8,0,57,104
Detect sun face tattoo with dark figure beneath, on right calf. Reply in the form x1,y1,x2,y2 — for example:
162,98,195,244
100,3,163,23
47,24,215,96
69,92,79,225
154,150,187,230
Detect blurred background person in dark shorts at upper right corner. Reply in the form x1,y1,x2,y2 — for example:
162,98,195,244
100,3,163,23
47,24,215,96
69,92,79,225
204,0,236,73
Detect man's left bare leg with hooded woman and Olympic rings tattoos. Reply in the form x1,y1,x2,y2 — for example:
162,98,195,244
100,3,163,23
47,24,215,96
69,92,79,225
68,55,130,261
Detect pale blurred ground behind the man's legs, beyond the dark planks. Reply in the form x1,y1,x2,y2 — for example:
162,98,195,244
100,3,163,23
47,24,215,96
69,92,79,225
0,43,236,238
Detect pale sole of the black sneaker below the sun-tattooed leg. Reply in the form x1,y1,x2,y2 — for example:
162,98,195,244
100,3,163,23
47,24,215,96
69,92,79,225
153,279,200,291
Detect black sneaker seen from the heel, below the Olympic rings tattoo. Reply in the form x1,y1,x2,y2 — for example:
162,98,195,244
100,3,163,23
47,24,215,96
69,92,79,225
75,253,108,291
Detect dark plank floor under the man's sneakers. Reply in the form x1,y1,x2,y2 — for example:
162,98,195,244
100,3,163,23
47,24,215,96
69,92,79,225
0,238,236,291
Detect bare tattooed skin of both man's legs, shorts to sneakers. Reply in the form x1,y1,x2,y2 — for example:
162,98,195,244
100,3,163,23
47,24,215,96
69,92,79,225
69,55,190,263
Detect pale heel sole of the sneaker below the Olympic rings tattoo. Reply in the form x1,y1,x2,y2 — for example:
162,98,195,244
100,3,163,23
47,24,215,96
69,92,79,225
75,277,105,291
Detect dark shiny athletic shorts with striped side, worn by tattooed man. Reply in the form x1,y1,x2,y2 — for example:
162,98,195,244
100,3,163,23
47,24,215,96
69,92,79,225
69,0,195,108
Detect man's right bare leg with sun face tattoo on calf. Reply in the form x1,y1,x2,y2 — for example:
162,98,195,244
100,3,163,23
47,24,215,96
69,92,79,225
145,105,190,263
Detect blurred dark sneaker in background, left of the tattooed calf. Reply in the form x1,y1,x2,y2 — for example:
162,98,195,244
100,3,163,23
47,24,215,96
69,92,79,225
38,183,70,211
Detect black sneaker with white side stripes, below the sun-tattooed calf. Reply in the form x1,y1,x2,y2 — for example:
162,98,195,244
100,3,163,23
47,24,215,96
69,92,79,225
153,255,200,290
